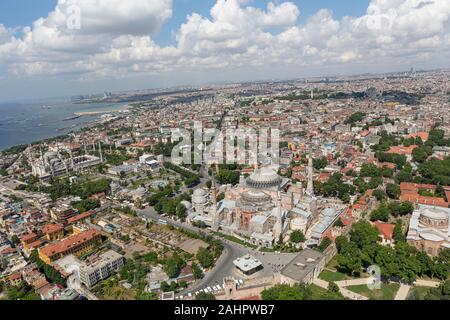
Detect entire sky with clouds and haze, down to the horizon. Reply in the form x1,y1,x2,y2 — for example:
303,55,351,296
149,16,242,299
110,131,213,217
0,0,450,101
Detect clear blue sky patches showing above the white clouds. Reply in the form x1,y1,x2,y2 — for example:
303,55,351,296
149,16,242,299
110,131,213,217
0,0,370,46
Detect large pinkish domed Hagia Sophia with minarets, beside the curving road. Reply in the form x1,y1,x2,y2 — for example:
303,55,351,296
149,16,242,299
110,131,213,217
188,158,344,248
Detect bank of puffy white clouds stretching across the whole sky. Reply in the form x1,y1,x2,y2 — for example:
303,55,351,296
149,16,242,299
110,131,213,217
0,0,450,79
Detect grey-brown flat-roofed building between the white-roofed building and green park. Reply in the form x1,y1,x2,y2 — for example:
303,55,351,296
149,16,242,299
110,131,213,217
280,249,326,285
